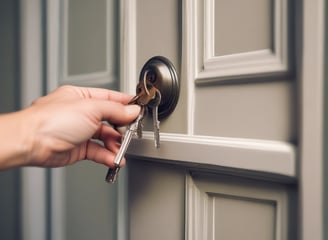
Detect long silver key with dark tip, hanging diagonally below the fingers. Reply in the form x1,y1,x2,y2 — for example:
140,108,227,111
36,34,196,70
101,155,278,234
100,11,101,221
106,106,145,183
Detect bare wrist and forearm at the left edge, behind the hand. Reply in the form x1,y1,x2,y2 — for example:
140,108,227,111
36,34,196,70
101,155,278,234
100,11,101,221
0,110,33,170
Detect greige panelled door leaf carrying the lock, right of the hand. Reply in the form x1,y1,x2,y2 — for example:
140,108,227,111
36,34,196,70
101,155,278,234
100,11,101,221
123,0,300,240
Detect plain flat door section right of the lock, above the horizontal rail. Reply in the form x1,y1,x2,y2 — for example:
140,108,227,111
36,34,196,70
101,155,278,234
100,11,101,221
194,79,298,142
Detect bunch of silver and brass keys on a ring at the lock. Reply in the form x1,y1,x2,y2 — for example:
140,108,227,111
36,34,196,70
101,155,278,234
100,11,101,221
106,73,161,183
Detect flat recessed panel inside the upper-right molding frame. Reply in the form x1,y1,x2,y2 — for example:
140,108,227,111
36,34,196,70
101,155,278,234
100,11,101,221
214,0,273,56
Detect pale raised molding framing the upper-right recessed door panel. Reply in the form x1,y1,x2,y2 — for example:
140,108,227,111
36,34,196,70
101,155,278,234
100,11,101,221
184,0,289,84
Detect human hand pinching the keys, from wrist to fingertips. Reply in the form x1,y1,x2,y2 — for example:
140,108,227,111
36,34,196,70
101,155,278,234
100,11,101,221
24,86,140,167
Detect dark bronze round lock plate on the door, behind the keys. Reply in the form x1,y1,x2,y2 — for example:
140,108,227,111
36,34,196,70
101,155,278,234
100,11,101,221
139,56,180,120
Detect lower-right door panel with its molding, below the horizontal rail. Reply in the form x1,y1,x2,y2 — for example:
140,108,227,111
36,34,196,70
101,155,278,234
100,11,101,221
186,172,297,240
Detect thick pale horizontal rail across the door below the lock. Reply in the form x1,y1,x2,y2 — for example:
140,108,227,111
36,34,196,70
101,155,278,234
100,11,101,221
128,132,297,179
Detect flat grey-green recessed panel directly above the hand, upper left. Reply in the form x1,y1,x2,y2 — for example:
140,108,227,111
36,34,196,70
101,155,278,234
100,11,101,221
66,0,109,76
